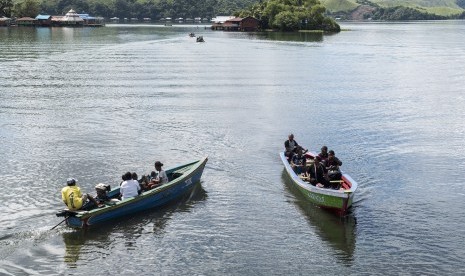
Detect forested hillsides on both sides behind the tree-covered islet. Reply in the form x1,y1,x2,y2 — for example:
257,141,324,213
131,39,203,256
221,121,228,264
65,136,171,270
0,0,465,20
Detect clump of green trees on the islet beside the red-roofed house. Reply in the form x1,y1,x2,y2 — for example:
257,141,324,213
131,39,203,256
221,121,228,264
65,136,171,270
235,0,341,32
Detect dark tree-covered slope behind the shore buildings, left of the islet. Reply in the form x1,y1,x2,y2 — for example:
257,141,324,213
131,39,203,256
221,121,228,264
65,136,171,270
0,0,257,20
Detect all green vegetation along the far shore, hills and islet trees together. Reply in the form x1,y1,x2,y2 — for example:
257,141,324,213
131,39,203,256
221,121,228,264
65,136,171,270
0,0,465,20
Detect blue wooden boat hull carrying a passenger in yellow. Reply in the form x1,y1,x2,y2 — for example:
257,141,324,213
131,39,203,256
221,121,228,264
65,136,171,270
56,157,208,228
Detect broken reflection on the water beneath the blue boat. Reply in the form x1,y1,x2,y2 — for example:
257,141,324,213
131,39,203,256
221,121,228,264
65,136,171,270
62,183,207,268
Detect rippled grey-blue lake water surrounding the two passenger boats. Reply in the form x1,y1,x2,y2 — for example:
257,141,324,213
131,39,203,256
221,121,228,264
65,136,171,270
0,21,465,275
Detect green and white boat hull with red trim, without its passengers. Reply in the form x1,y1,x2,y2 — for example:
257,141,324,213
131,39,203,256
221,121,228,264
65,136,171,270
279,152,358,216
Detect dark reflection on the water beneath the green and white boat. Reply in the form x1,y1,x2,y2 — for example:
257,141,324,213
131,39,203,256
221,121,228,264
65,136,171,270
282,170,356,265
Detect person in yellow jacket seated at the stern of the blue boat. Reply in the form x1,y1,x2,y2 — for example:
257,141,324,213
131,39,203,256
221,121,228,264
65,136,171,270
61,178,100,211
